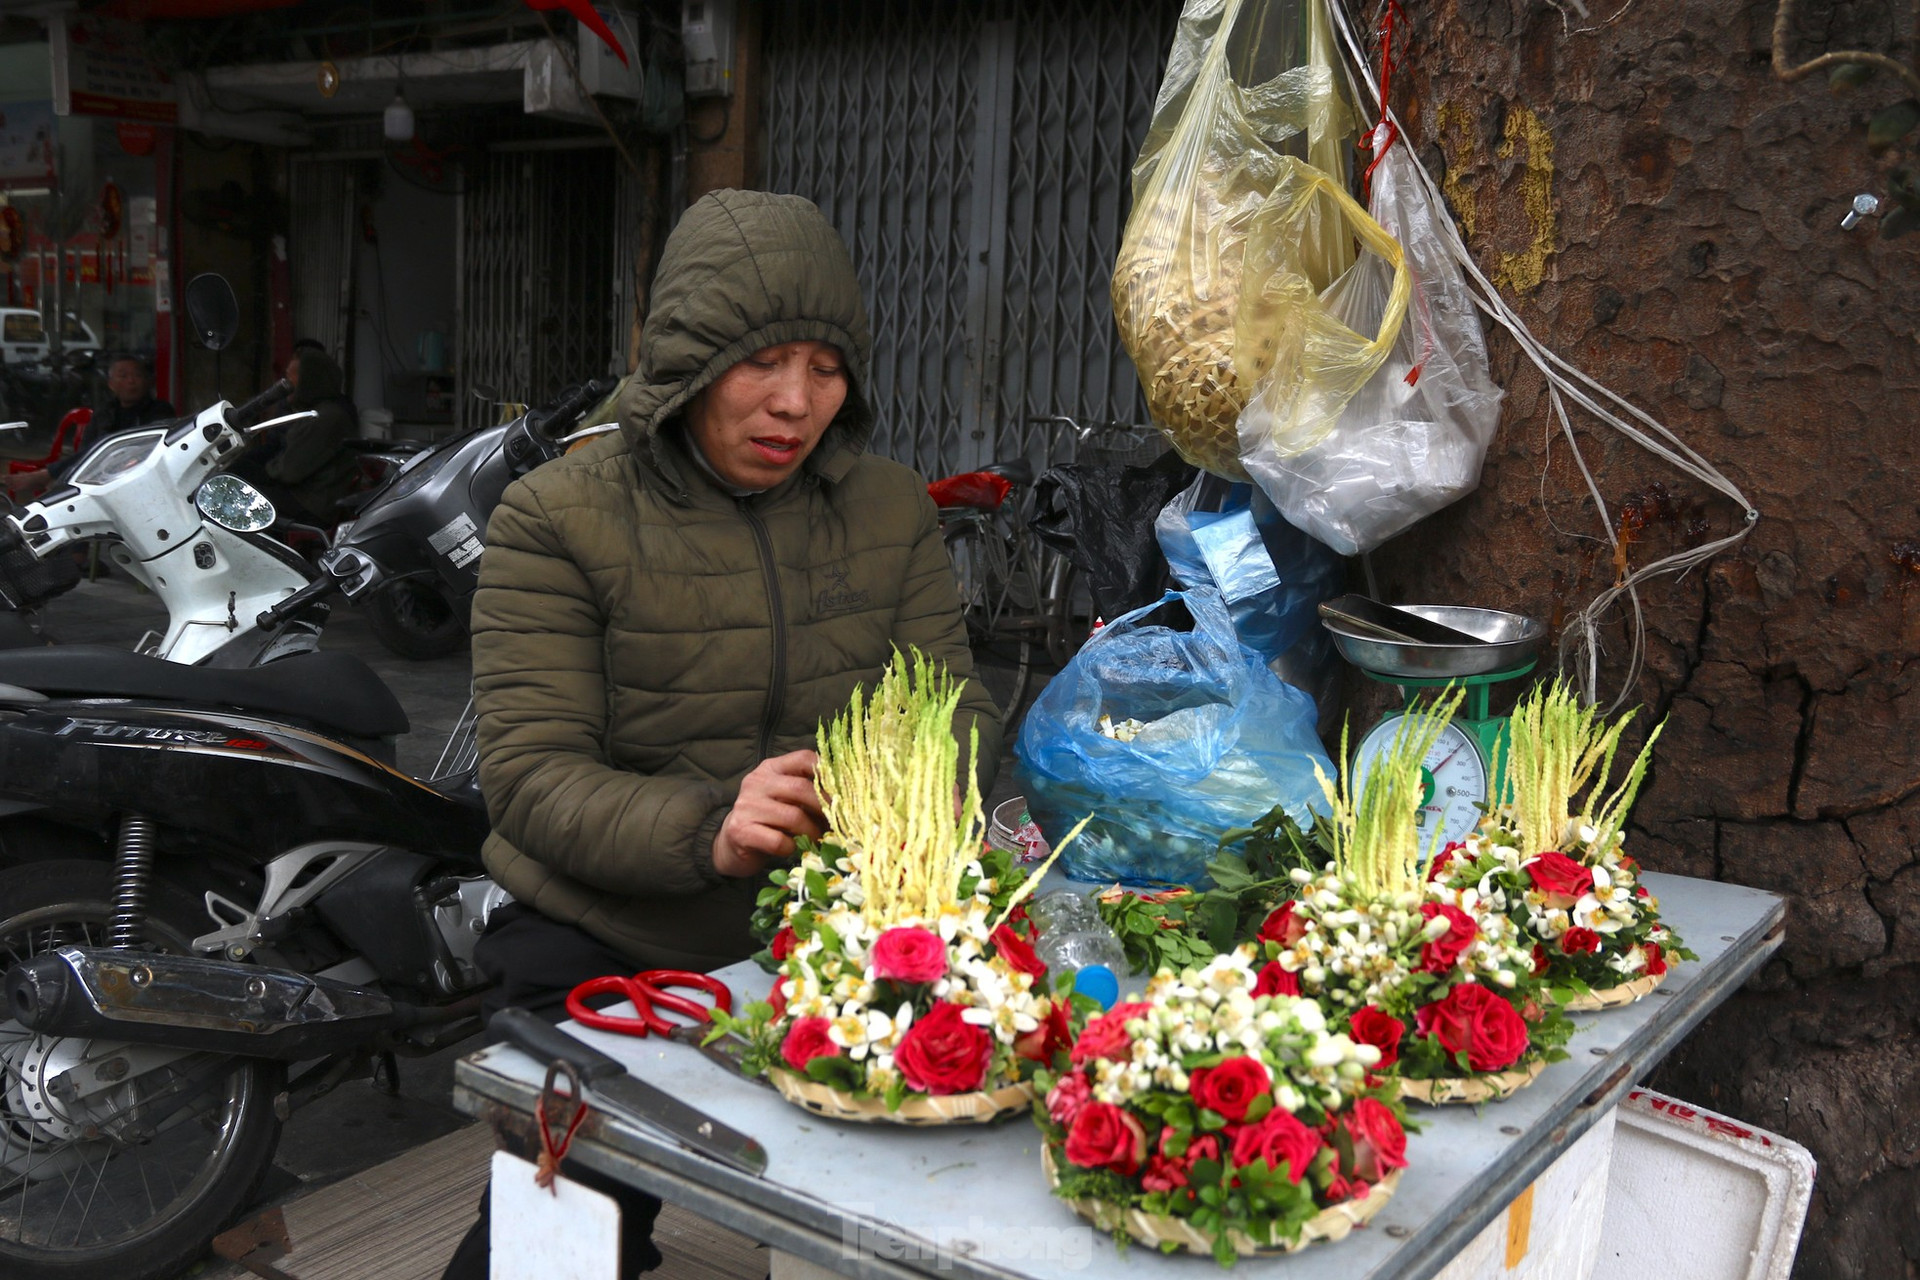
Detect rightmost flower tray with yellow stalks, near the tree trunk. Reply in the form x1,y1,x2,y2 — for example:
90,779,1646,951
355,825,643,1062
1432,681,1693,1011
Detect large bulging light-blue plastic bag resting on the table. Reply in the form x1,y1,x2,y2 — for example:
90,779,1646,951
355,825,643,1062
1014,591,1334,885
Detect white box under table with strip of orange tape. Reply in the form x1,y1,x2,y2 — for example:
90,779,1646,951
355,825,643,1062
1436,1111,1612,1280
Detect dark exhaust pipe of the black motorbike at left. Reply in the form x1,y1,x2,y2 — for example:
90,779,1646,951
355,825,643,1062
4,946,420,1061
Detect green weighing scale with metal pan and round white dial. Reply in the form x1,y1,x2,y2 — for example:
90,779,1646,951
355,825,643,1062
1321,597,1546,848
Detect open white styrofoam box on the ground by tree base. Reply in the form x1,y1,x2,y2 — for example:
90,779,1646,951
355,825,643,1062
1594,1088,1814,1280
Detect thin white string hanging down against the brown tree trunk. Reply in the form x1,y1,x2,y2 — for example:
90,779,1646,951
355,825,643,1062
1327,0,1761,714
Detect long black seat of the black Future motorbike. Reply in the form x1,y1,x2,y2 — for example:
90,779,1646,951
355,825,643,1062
0,645,409,737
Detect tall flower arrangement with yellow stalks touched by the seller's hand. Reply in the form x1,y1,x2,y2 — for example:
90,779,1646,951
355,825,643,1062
714,652,1071,1125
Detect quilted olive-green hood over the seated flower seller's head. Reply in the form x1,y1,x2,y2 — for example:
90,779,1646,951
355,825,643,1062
620,190,874,491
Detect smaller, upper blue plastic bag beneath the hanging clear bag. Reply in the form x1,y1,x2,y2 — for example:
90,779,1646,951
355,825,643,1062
1154,476,1346,662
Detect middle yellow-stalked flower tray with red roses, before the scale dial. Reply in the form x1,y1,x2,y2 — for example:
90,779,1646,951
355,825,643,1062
1258,693,1572,1103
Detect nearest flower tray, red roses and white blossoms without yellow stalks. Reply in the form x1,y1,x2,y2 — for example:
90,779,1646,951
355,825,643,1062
1035,946,1407,1265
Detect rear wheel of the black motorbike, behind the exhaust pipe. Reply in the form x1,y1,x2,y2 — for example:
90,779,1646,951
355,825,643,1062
0,862,280,1280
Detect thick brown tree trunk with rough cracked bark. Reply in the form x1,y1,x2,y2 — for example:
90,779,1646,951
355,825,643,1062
1377,0,1920,1280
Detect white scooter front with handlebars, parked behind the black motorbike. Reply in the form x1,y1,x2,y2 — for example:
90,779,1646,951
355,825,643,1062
10,391,317,666
